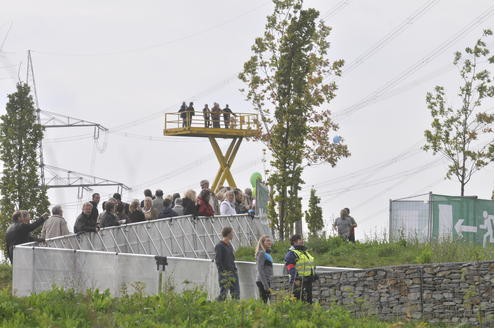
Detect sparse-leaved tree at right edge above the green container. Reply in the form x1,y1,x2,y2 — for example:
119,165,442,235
423,30,493,196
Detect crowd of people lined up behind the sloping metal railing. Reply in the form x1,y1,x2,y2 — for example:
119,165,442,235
6,180,255,262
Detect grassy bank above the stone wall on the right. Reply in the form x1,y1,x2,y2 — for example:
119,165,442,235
236,237,493,268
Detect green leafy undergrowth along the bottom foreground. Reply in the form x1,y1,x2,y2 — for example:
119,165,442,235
0,289,436,328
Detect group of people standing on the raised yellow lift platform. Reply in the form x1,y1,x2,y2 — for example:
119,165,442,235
179,101,236,129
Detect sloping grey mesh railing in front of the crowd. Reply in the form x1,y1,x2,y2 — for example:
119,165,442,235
28,215,270,259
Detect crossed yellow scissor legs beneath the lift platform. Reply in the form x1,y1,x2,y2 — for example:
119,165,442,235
208,137,242,192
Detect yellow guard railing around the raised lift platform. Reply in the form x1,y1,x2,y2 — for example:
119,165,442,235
165,112,259,130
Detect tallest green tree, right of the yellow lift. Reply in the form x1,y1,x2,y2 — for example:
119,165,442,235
239,0,350,239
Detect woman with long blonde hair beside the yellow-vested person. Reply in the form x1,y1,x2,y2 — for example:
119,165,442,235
256,235,273,303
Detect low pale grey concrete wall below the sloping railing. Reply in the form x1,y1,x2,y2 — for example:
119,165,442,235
13,245,352,299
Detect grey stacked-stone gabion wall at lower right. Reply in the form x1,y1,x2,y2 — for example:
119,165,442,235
274,262,494,327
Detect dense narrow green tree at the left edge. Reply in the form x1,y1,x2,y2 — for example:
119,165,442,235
0,83,49,251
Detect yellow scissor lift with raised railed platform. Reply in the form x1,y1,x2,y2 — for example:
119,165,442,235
163,113,260,192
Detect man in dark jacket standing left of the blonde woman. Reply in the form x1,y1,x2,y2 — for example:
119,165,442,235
215,227,240,301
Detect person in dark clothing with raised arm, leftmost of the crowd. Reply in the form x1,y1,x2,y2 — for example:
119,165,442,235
5,210,50,263
